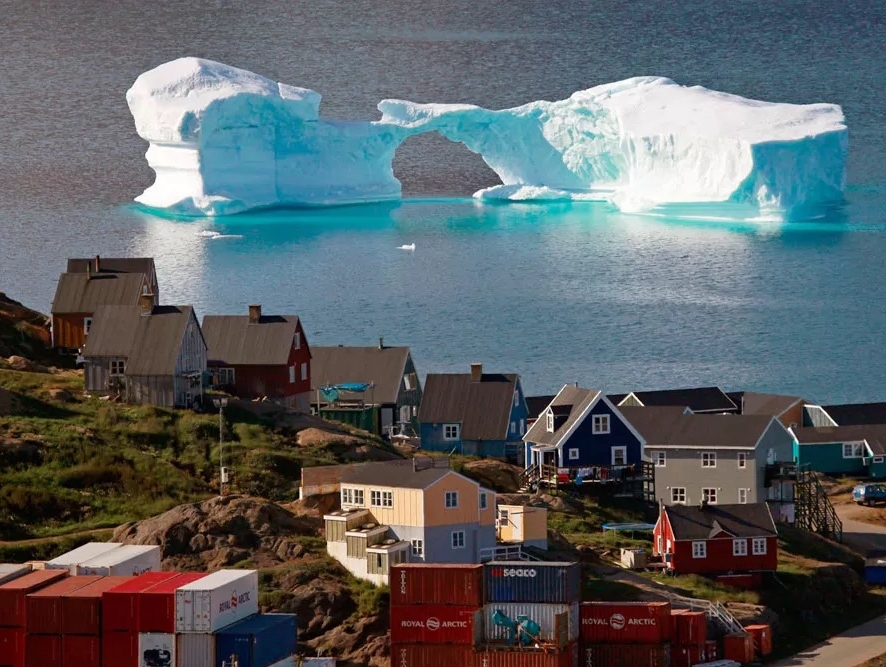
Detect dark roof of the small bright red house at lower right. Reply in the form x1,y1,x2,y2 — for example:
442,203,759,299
664,503,778,540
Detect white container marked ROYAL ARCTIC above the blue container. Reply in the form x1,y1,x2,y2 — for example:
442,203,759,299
175,570,258,636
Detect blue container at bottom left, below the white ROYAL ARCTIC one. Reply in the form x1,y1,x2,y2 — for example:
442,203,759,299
215,614,297,667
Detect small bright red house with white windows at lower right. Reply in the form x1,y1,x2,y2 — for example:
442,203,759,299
653,503,778,575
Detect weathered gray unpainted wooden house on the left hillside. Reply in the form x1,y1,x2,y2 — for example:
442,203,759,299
83,294,206,407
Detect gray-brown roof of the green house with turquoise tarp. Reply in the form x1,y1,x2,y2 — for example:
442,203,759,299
311,345,419,403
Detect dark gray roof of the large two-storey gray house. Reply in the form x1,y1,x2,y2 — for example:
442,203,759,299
619,406,773,449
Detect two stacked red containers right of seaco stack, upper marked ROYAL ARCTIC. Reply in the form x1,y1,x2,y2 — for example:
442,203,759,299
580,602,673,667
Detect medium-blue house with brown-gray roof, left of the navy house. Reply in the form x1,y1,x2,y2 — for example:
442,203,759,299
418,364,529,463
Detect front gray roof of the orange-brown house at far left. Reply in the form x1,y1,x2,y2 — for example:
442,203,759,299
52,273,146,315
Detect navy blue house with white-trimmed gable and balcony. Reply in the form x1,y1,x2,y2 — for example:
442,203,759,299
523,384,645,469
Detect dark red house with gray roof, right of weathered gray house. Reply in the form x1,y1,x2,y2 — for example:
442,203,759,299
203,305,311,412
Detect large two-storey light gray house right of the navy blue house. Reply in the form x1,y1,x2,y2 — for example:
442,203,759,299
619,407,794,520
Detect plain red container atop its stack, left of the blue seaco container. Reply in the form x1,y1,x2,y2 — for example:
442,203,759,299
389,563,483,607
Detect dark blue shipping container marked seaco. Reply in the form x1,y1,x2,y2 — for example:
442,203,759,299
483,560,581,604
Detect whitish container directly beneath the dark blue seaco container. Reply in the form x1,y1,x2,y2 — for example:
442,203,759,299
483,602,581,648
